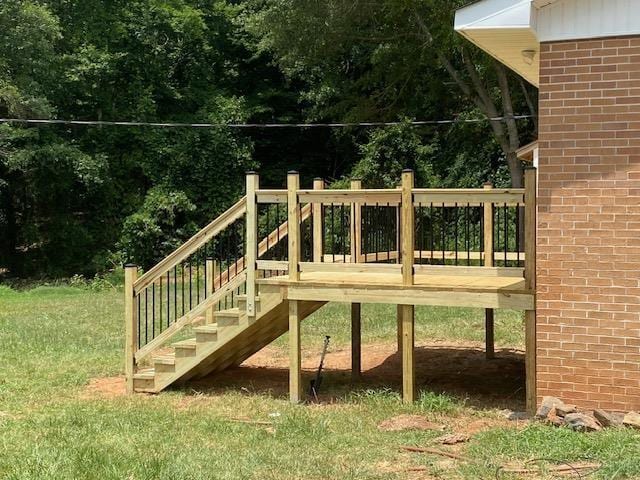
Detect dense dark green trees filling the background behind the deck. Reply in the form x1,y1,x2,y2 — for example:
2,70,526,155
0,0,536,277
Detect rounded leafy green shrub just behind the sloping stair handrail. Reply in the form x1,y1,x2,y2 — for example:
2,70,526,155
119,188,196,268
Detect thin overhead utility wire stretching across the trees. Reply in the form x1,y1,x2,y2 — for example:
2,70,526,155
0,115,533,128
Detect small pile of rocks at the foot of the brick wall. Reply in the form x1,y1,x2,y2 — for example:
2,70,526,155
536,397,640,432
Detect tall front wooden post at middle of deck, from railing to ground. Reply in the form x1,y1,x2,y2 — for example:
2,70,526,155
398,170,416,403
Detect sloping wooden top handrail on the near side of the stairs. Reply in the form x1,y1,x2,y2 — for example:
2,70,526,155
133,197,247,295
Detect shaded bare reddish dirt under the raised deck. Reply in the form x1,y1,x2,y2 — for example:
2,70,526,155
176,346,525,411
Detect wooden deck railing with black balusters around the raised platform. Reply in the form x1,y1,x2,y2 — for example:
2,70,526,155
247,169,536,294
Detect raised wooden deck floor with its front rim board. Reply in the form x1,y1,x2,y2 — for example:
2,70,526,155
258,271,534,310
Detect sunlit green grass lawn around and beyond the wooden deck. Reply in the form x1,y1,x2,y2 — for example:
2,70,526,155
0,287,640,480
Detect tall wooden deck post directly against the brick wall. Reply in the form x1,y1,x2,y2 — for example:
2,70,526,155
524,167,538,413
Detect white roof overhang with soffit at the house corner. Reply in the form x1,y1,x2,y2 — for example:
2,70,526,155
455,0,540,85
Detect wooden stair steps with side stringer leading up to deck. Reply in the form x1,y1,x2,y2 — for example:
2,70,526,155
133,286,324,393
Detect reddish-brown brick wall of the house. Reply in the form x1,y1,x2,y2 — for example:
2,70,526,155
537,37,640,410
